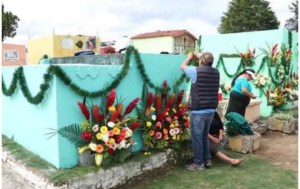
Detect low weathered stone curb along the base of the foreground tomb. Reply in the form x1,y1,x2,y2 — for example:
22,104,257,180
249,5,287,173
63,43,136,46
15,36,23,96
2,148,193,189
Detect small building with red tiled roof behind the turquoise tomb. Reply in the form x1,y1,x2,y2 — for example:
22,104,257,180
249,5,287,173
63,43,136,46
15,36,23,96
131,30,197,54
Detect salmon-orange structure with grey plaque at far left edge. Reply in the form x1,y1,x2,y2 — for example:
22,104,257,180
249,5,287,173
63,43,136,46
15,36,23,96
2,43,26,66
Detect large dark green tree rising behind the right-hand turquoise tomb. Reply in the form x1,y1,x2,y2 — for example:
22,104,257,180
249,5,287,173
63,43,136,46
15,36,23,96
218,0,280,33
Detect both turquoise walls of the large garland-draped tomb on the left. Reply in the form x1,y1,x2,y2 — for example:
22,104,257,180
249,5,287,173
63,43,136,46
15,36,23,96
2,54,185,168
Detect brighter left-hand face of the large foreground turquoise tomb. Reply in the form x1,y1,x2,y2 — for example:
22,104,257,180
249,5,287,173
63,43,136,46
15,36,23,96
2,66,60,167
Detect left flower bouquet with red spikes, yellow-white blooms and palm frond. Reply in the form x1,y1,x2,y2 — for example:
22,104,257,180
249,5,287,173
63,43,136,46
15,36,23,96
48,90,141,166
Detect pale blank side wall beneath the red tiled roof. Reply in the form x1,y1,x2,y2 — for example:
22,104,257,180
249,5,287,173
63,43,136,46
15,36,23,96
131,37,174,54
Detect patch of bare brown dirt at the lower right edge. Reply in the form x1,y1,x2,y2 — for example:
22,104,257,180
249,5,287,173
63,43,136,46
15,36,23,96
255,130,298,172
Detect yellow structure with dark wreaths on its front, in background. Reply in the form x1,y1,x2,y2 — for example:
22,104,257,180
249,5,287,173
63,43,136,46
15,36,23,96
28,35,100,64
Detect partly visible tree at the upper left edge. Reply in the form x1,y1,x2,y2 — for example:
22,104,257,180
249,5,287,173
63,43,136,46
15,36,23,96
2,4,20,42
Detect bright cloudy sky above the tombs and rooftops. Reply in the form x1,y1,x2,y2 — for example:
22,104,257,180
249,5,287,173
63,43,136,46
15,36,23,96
2,0,293,45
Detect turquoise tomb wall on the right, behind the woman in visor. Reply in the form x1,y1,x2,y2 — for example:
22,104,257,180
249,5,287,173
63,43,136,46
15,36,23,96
201,29,298,116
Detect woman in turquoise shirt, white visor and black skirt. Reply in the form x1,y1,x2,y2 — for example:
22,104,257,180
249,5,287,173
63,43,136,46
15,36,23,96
226,69,256,117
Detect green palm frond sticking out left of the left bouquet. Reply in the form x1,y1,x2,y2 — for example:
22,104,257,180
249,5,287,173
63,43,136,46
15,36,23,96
57,124,89,147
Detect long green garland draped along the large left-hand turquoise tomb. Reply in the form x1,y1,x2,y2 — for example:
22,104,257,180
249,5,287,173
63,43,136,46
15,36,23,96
2,46,187,104
